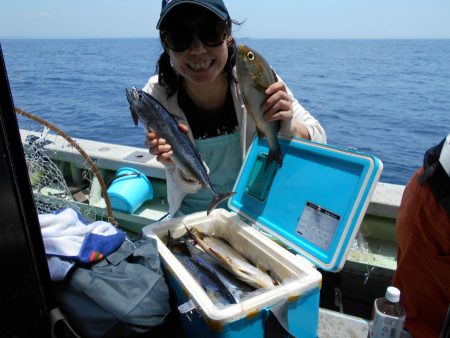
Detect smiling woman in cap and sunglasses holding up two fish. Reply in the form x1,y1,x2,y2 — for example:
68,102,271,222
144,0,326,215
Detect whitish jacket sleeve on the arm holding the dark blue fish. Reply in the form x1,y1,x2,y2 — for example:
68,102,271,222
142,76,201,216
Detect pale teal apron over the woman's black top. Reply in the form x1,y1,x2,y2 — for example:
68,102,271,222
178,132,242,215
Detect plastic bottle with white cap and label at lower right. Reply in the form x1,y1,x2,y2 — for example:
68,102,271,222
369,286,405,338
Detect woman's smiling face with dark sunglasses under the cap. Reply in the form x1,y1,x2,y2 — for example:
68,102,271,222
165,7,231,85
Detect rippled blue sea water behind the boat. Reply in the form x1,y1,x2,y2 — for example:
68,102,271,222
0,39,450,184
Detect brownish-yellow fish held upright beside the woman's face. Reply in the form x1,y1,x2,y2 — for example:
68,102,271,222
236,45,283,170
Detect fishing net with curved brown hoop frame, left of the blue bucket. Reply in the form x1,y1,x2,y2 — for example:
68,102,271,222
16,108,116,224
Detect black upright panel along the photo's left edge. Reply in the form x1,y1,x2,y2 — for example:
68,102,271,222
0,44,53,338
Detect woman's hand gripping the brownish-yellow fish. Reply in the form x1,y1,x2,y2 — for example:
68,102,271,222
261,81,294,122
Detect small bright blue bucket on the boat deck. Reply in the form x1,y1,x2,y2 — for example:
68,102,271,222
108,168,153,214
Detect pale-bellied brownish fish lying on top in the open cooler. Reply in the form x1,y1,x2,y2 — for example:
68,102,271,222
186,227,274,288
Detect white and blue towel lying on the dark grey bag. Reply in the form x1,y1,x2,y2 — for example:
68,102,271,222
39,208,125,281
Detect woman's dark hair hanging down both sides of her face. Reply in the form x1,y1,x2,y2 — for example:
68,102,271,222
156,7,240,97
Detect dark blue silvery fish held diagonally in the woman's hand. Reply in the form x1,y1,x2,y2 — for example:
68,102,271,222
126,88,235,215
